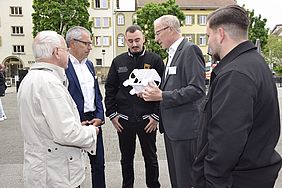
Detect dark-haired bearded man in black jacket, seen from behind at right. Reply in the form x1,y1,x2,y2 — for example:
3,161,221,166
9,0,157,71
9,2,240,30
193,5,281,188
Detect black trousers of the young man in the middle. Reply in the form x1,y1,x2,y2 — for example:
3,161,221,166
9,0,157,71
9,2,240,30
118,118,160,188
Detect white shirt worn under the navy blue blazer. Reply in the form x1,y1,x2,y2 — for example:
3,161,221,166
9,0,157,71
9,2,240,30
69,54,96,112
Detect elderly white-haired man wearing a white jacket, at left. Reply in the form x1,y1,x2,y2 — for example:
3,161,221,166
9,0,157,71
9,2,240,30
18,31,99,188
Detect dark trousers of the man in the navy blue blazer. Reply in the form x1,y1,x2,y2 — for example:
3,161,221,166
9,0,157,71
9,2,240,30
82,113,106,188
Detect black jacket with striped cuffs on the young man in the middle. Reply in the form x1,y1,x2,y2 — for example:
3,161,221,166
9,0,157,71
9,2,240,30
105,51,164,121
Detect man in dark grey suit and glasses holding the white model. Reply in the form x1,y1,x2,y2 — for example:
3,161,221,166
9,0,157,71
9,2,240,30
142,15,205,188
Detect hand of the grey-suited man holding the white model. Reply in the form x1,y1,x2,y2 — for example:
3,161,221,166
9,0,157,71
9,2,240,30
142,82,163,101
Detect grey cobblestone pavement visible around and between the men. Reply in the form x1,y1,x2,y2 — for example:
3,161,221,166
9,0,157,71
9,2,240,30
0,85,282,188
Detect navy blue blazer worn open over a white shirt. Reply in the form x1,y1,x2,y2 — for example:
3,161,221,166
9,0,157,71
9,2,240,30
66,60,105,121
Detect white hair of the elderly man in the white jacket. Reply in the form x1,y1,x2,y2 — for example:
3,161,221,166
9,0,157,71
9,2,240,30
32,31,62,59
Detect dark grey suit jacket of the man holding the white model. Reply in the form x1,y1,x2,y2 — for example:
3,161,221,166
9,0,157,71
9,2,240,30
160,39,205,140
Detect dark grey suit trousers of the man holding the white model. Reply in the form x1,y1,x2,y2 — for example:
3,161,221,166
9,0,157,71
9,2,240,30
164,134,197,188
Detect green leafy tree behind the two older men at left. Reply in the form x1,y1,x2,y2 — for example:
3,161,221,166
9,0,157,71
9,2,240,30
32,0,92,36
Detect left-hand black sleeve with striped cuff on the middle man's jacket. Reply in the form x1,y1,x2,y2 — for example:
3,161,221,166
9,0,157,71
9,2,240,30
105,60,119,119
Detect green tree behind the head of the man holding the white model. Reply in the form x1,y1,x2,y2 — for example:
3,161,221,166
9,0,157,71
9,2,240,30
137,0,185,59
